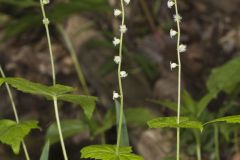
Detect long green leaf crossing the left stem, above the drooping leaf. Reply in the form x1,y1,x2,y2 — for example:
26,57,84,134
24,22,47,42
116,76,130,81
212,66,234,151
0,78,74,98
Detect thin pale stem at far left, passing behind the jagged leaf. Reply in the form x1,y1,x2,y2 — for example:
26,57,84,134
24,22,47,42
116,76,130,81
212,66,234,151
0,66,30,160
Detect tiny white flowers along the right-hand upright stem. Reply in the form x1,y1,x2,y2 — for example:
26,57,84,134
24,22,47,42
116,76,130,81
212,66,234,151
167,0,187,70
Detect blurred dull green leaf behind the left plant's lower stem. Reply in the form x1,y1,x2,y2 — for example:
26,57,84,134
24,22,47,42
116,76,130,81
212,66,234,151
46,120,88,144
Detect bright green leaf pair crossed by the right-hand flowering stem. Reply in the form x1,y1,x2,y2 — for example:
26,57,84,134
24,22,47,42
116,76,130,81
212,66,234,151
148,117,203,131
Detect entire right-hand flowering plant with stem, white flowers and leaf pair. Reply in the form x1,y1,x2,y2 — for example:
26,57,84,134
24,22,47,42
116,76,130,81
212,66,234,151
148,0,203,160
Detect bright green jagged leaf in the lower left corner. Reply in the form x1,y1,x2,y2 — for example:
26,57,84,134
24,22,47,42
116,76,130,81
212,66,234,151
0,120,38,154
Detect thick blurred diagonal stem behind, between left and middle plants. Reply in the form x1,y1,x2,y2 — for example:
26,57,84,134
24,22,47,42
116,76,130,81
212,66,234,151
57,25,90,95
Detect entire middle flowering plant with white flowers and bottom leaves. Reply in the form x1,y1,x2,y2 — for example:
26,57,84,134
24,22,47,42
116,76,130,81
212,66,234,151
81,0,143,160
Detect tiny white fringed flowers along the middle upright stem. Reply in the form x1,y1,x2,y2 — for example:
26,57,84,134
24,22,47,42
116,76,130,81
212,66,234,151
113,0,130,100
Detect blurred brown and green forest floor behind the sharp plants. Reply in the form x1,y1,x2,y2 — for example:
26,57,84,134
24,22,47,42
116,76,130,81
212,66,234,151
0,0,240,160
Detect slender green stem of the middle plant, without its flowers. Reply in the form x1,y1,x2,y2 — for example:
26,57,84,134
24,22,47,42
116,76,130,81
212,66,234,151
116,0,125,155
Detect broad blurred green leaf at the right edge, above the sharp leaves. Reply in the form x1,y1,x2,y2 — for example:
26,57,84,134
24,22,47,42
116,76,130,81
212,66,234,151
207,58,240,93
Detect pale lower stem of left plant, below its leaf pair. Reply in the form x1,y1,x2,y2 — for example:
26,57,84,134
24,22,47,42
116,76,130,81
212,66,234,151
53,97,68,160
